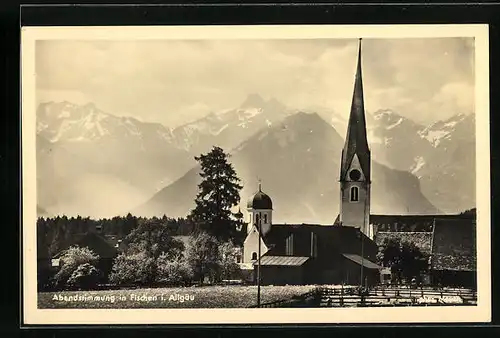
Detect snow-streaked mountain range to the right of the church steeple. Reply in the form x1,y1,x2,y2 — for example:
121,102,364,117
326,109,476,212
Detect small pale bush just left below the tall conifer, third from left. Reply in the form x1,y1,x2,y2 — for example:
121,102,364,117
156,254,193,285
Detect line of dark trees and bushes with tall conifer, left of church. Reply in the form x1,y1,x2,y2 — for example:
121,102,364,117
37,147,246,290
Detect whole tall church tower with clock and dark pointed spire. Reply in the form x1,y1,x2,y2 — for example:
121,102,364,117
339,39,371,236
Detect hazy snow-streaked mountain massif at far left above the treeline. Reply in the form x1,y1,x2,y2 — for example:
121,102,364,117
37,102,195,216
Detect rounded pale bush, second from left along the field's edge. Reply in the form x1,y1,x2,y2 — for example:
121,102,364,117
109,252,156,285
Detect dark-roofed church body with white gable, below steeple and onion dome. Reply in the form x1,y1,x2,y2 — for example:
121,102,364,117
243,220,380,285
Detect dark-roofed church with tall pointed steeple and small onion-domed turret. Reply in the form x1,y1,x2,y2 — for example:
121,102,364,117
243,39,381,285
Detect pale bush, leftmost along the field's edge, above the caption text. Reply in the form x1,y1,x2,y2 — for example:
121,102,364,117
54,246,99,287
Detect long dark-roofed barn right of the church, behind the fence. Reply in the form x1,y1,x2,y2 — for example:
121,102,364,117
370,212,476,287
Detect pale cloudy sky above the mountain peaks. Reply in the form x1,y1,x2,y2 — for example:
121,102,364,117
36,38,475,127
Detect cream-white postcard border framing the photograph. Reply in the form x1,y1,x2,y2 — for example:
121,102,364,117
21,24,491,325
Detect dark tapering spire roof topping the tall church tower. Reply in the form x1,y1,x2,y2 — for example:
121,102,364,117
340,39,371,182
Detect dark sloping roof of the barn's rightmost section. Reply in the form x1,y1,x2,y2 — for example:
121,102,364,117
431,219,476,271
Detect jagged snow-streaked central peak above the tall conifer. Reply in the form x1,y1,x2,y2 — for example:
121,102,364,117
172,94,292,155
